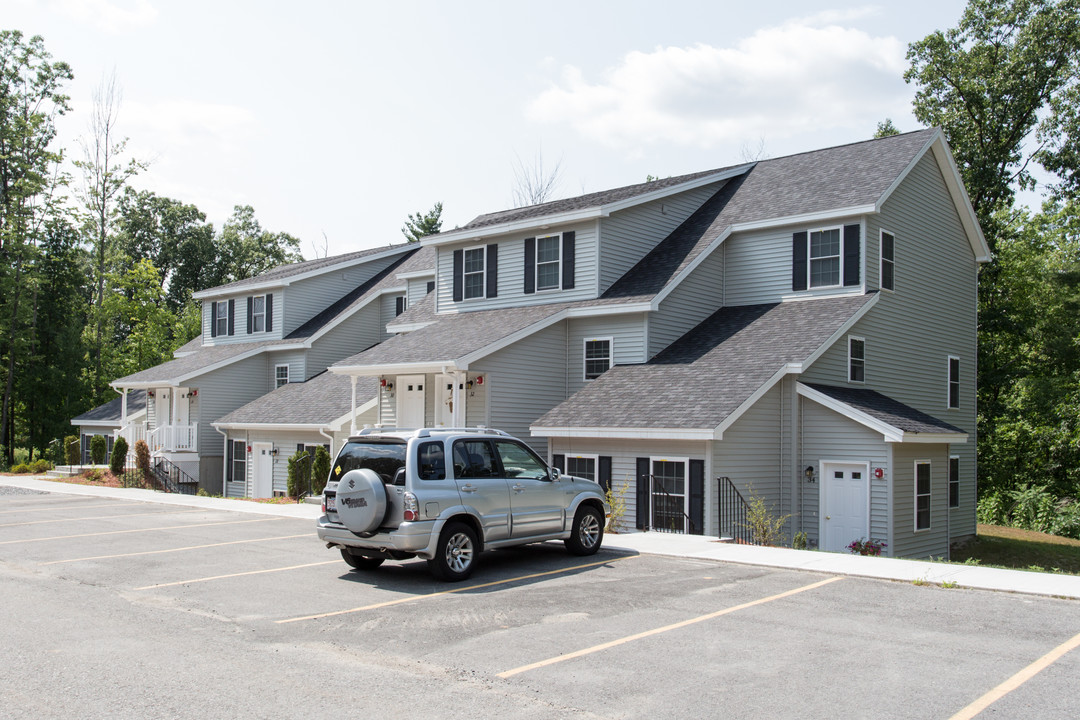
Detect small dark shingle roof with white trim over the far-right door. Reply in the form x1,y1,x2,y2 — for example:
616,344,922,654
798,382,968,443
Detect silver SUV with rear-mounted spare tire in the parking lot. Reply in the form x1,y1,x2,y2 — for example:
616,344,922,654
319,427,610,581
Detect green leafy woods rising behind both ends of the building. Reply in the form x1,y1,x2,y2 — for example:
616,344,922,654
0,0,1080,536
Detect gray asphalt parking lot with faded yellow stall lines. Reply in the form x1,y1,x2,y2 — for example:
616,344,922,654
0,493,1080,718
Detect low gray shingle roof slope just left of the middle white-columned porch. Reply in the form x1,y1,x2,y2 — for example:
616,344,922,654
215,372,378,425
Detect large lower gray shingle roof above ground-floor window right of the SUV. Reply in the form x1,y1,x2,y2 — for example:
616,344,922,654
532,295,874,430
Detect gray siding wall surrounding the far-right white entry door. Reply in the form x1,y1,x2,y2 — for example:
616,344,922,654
796,397,892,555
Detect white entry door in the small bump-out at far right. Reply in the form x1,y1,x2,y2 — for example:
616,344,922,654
821,462,870,553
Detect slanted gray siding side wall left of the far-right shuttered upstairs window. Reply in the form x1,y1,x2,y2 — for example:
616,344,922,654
648,245,725,358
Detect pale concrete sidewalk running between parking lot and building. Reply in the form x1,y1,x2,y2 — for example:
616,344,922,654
0,476,1080,599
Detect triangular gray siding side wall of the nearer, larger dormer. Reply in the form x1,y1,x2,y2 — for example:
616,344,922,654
599,182,724,293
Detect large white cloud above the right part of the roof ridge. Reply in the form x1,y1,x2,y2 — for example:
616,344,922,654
527,16,910,149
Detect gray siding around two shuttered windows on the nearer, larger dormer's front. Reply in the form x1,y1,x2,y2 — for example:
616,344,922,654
435,222,597,313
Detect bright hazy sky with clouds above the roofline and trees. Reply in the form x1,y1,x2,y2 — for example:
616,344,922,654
8,0,964,258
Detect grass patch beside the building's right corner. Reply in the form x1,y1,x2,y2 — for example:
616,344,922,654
953,525,1080,575
